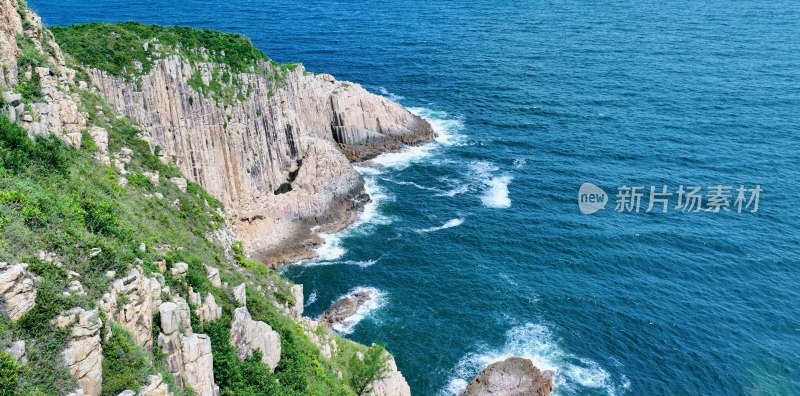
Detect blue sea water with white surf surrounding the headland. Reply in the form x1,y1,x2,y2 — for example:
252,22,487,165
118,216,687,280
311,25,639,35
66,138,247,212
29,0,800,395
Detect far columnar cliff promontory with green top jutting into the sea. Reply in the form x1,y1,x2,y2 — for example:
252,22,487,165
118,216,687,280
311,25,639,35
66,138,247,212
49,23,433,261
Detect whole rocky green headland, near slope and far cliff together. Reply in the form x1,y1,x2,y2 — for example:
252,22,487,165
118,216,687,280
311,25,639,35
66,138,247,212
0,0,422,396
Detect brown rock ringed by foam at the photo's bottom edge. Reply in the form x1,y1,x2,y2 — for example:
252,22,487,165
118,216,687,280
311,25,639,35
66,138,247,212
462,357,553,396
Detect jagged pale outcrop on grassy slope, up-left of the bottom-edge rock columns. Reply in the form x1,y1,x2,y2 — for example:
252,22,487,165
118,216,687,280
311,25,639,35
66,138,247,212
100,269,161,350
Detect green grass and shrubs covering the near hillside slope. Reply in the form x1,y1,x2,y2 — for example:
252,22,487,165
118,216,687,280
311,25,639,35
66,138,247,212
0,104,388,395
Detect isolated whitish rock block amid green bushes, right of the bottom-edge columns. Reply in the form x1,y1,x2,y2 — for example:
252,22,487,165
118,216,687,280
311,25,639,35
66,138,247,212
231,307,281,371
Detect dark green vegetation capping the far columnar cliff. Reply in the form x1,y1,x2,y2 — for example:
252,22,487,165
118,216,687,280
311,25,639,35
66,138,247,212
51,22,299,105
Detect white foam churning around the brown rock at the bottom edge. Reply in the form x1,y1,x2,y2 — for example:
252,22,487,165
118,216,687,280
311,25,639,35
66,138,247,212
439,323,630,396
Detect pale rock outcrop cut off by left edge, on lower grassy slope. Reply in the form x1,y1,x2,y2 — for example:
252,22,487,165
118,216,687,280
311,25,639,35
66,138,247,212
0,263,36,320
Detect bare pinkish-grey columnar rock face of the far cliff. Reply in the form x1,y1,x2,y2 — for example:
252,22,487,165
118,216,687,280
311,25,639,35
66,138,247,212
90,55,433,258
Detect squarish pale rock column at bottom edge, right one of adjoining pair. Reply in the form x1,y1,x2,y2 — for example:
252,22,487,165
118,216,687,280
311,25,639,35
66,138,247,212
181,334,219,396
